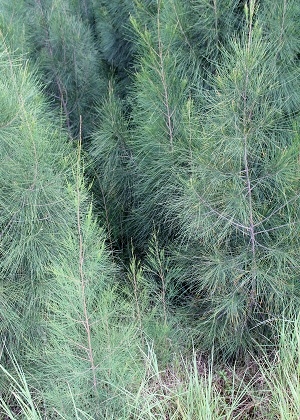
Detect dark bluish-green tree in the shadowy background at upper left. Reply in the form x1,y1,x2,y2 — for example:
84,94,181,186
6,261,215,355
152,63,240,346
3,0,106,138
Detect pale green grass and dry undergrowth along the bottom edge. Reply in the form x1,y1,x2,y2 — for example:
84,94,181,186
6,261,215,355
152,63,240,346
0,317,300,420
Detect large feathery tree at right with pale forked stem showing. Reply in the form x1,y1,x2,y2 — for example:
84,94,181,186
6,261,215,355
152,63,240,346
169,1,300,355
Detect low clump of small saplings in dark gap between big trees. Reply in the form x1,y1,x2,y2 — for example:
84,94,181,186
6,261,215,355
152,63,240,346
128,235,191,365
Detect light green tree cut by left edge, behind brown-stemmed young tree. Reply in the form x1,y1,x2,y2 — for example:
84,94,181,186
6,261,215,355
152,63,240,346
0,39,74,360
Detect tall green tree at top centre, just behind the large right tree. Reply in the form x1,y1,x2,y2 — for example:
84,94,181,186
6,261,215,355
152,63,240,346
126,0,246,248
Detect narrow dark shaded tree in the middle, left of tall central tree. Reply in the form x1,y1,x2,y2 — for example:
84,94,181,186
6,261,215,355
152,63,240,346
90,84,132,249
